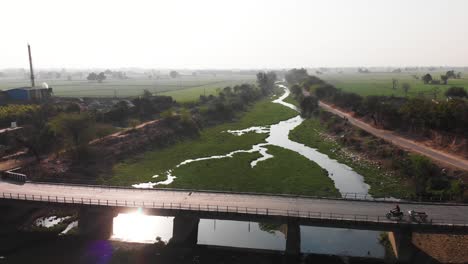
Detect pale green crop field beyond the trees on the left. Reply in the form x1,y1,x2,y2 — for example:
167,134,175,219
0,75,256,102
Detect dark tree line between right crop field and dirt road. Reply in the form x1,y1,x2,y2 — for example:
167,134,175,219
287,70,468,137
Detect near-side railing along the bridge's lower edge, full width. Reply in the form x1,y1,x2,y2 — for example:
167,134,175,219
0,192,468,227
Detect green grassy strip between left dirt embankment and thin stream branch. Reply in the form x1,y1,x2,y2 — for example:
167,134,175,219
106,99,296,185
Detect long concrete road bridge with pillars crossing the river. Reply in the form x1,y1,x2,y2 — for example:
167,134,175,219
0,181,468,260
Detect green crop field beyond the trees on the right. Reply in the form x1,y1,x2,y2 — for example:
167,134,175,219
318,72,468,99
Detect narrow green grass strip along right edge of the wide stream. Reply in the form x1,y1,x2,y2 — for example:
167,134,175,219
289,117,413,197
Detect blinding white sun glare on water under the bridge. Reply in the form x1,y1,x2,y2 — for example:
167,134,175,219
111,209,173,243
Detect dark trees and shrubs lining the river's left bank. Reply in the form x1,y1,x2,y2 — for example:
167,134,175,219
0,72,276,163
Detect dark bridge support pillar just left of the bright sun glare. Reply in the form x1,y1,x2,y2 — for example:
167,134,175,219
78,208,117,239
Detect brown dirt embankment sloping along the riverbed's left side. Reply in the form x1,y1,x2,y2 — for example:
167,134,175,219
33,117,198,183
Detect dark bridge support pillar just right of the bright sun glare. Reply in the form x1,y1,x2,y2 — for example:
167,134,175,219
170,215,200,247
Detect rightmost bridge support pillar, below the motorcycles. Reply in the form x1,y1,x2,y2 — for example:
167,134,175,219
388,230,415,263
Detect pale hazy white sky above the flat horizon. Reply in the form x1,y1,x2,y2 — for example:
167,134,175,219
0,0,468,68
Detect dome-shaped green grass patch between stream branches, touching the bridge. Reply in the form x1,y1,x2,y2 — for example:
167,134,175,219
170,146,339,196
